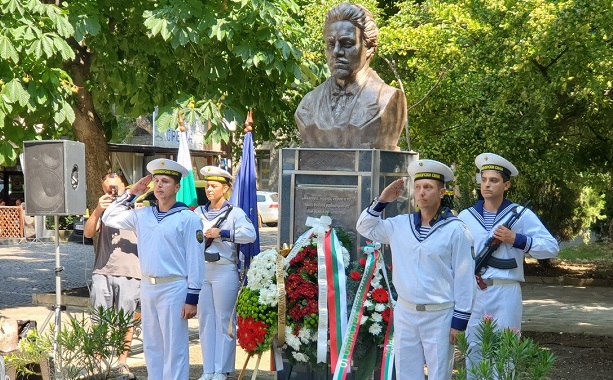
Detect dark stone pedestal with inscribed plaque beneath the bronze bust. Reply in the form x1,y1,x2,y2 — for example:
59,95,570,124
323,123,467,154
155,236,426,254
278,148,419,260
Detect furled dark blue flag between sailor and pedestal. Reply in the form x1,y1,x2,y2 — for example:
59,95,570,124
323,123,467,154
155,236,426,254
230,132,260,269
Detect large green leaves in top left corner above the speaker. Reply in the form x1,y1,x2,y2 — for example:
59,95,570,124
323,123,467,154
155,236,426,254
0,0,77,165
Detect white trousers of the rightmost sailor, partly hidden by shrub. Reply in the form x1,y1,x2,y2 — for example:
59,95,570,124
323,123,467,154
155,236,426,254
466,282,522,380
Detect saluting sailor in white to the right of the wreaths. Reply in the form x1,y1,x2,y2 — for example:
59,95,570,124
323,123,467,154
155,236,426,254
356,160,475,380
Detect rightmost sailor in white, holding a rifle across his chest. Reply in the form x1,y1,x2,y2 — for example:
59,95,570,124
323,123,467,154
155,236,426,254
458,153,559,379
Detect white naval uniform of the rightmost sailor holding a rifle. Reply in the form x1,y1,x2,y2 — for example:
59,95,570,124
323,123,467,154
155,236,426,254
458,199,560,378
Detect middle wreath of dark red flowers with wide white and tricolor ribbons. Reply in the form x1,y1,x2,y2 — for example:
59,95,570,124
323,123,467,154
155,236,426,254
284,217,351,370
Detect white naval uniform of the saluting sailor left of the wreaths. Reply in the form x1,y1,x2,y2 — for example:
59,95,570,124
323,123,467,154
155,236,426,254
102,193,204,380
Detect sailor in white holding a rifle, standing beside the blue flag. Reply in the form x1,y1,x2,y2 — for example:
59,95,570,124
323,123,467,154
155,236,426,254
194,166,256,380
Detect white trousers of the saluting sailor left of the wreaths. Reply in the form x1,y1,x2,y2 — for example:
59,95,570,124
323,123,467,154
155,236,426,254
141,280,189,380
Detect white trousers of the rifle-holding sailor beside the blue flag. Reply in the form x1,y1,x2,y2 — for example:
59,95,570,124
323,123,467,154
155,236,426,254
198,263,239,373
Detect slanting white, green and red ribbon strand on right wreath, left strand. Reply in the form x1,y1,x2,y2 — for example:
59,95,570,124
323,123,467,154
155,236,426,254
332,243,381,380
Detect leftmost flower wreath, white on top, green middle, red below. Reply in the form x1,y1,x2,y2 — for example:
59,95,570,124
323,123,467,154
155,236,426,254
236,249,279,355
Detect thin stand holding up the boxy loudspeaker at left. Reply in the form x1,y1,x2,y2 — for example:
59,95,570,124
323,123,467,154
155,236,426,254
39,215,72,379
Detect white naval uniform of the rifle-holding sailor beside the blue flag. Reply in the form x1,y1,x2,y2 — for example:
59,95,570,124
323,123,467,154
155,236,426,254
194,202,256,374
